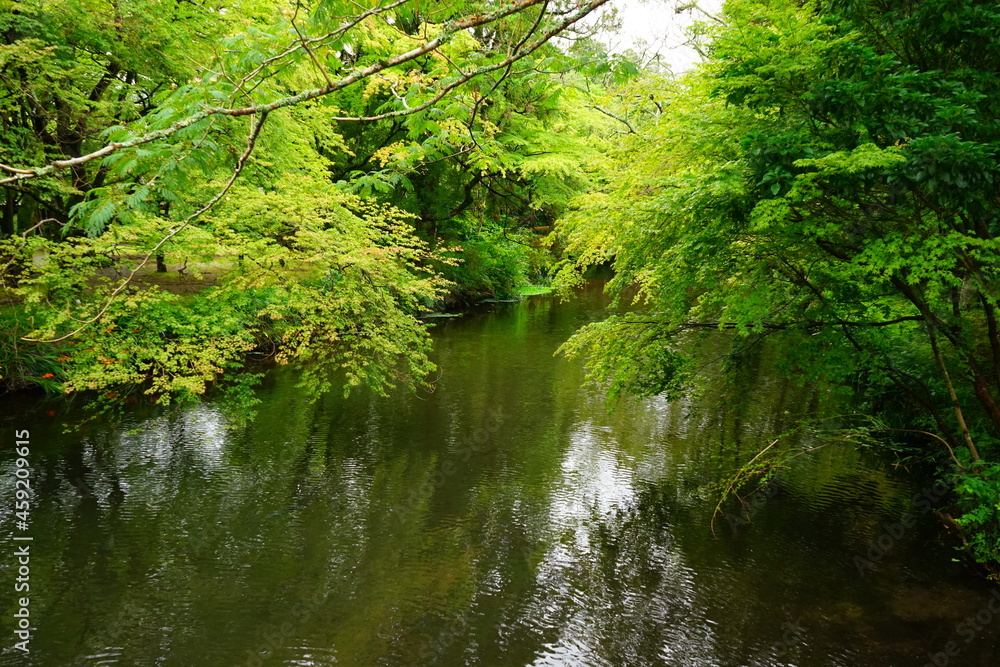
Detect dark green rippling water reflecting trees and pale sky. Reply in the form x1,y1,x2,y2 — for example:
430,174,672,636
0,284,1000,667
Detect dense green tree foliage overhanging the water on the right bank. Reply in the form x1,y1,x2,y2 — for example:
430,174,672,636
562,0,1000,576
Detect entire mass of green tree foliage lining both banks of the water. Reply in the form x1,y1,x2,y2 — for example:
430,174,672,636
0,0,1000,576
